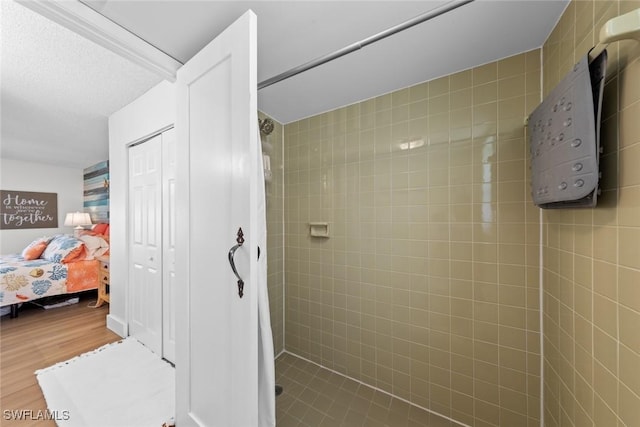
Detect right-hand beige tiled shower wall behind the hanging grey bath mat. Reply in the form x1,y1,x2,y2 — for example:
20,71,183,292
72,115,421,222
543,0,640,427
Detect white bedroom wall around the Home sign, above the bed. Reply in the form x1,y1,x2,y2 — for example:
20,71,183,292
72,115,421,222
0,159,84,254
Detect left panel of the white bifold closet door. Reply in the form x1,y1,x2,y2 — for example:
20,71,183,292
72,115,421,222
129,135,162,354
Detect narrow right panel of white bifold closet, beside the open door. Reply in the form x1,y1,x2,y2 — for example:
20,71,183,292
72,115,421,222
162,129,178,363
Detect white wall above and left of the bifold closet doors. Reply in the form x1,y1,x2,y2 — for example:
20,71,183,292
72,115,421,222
107,82,176,337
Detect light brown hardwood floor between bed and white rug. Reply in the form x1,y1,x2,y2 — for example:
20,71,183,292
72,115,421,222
0,293,120,427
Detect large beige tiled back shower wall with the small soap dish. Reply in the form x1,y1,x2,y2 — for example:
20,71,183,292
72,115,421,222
284,50,541,426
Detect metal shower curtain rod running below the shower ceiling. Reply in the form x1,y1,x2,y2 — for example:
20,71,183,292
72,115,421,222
258,0,474,90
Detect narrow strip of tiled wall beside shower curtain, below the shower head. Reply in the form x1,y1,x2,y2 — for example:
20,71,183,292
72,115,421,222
258,112,284,356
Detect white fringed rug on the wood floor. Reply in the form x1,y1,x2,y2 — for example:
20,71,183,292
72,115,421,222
36,337,175,427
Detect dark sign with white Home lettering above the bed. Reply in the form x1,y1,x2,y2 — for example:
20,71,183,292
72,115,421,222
0,190,58,230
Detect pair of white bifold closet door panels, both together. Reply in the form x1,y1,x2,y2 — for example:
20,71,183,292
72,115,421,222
128,129,176,362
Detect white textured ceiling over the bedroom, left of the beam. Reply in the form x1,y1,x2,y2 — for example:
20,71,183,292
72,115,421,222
0,0,161,168
